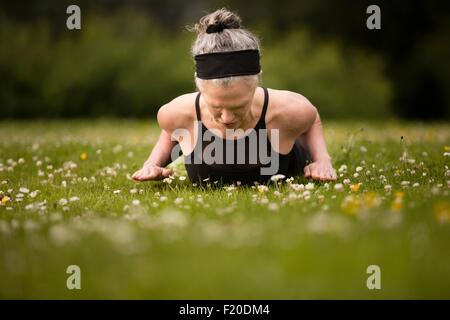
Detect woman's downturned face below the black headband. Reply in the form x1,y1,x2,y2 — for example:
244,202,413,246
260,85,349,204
201,80,256,129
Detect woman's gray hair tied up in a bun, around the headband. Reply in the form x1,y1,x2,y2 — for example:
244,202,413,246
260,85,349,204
188,8,262,90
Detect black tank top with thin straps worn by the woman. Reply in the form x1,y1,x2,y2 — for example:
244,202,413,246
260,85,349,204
184,87,295,184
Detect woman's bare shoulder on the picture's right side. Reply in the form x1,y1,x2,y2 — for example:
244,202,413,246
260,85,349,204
267,89,317,133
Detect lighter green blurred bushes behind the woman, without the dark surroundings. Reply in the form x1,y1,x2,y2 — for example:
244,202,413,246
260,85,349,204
0,11,391,118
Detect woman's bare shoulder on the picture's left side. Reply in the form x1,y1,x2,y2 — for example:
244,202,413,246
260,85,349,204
157,92,197,132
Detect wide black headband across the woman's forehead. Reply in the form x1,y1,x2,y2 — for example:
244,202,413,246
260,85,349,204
195,50,261,79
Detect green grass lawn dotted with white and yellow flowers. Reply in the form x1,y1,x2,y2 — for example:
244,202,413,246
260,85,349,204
0,120,450,299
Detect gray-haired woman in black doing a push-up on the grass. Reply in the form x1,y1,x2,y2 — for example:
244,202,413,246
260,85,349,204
133,9,336,183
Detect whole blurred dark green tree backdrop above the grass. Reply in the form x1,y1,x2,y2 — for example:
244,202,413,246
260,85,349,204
0,0,450,119
